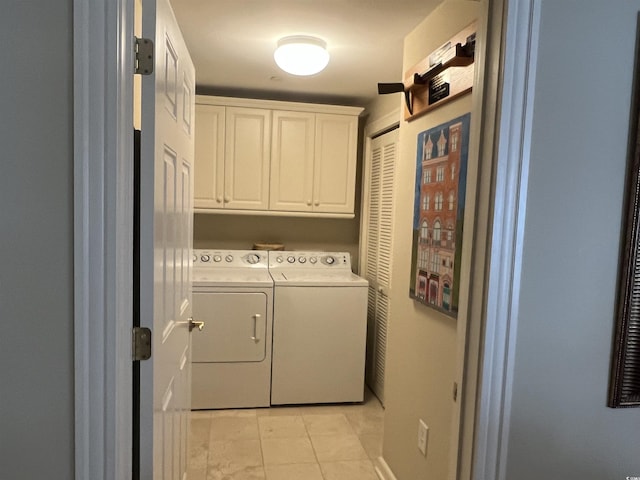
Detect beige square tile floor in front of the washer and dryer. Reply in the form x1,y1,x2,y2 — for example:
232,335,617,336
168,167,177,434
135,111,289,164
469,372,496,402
188,391,384,480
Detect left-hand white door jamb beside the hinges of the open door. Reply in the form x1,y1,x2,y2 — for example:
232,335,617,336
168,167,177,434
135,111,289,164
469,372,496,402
73,0,133,480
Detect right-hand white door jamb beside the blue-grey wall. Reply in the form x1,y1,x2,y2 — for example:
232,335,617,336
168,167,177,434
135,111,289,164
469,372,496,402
468,0,541,480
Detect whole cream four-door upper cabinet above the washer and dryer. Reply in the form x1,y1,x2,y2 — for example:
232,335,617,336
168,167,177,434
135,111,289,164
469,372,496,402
195,96,362,218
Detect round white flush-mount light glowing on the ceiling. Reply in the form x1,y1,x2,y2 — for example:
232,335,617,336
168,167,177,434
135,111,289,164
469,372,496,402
273,35,329,76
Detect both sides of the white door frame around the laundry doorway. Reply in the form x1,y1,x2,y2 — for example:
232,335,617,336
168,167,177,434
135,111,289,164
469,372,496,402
73,0,540,480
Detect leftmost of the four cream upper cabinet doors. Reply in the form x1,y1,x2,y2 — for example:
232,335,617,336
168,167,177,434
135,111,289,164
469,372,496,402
194,105,224,209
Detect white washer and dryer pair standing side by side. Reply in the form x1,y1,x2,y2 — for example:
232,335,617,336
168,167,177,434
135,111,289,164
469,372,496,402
192,250,368,409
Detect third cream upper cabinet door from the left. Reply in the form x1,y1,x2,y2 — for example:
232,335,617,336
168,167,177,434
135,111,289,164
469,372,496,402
269,110,315,212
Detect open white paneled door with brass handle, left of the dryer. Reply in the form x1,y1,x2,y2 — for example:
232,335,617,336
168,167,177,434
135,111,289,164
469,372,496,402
140,0,195,480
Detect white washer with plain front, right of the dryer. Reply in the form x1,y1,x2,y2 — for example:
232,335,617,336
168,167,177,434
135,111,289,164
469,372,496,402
269,251,368,405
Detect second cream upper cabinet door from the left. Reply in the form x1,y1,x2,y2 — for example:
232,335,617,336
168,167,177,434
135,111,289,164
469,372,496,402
224,107,271,210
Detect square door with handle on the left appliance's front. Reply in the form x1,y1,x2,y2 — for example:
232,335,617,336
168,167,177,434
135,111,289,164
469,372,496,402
192,292,267,363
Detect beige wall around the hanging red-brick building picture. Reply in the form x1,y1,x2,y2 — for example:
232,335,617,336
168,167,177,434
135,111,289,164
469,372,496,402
370,1,480,480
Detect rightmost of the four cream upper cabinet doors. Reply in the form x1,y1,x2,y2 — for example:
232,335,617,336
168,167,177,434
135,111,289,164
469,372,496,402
313,114,358,213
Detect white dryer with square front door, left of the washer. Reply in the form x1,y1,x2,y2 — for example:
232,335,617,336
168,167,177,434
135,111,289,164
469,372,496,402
191,250,273,409
